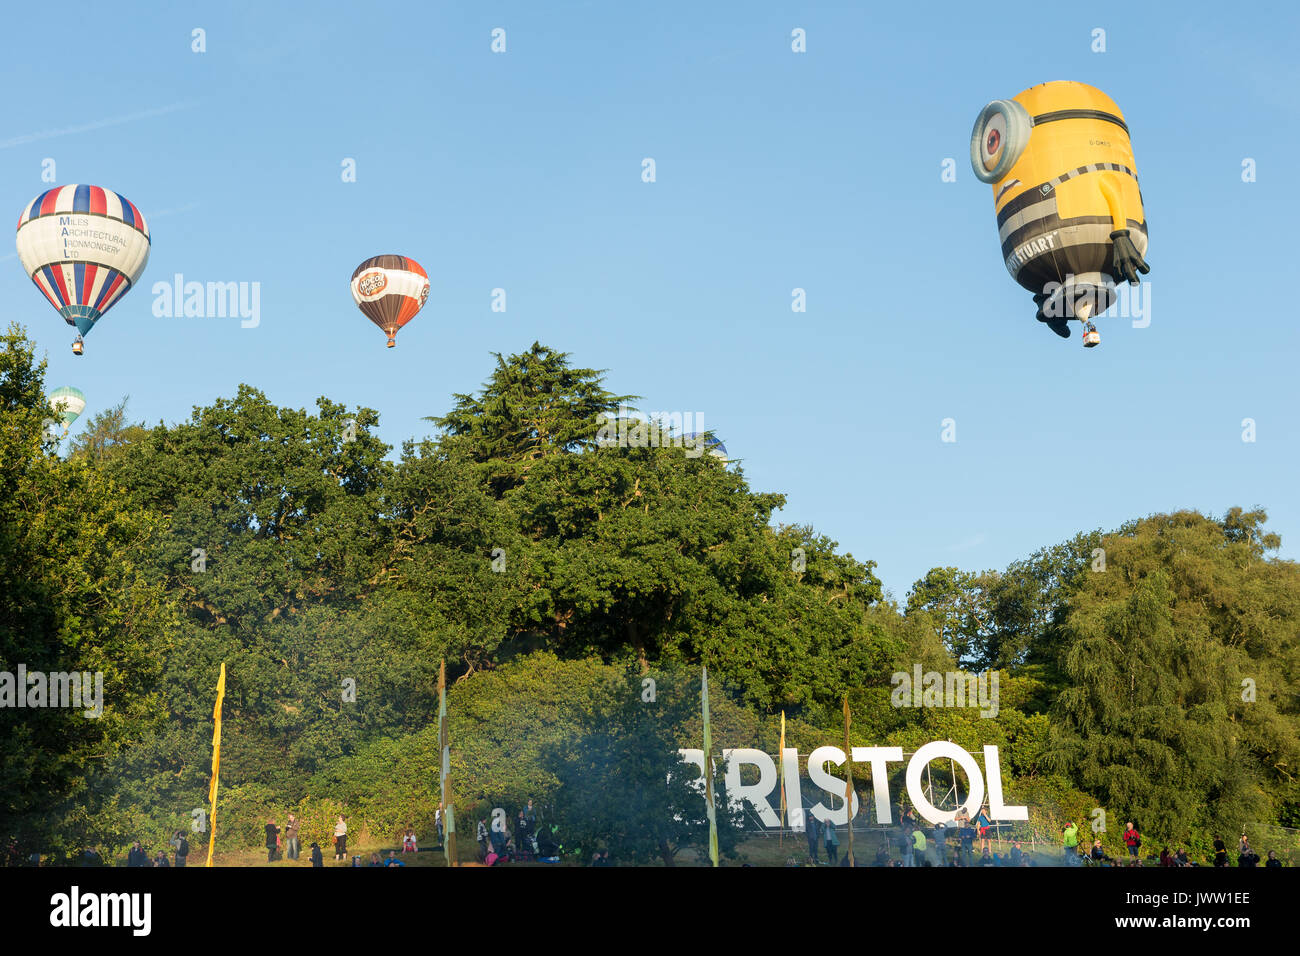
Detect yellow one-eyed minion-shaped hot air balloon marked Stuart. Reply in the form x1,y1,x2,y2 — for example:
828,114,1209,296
971,81,1151,346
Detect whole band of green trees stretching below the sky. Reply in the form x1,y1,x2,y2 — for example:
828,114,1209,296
0,328,1300,861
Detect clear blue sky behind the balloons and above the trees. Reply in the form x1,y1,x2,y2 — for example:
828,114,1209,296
0,3,1300,598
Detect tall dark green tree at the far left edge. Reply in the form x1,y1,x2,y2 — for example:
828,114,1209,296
0,325,173,851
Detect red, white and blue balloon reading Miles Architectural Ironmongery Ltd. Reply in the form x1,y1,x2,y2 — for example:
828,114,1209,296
17,186,150,355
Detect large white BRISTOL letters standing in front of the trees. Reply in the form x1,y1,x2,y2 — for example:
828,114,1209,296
679,740,1030,830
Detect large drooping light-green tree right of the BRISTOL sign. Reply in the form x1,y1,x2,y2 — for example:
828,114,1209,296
1045,509,1300,840
